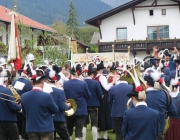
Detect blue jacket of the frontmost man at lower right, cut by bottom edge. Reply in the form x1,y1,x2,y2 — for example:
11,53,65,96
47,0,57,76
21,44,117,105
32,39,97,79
122,105,160,140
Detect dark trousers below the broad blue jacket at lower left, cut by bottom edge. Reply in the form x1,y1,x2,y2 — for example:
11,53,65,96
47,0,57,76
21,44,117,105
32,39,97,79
28,132,54,140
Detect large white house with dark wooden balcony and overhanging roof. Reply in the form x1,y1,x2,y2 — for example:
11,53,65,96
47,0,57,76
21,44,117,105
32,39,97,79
86,0,180,58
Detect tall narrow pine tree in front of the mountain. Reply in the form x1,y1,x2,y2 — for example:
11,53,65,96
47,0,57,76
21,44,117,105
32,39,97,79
66,1,79,40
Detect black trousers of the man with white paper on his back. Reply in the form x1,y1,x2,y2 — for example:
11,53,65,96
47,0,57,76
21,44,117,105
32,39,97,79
16,112,28,139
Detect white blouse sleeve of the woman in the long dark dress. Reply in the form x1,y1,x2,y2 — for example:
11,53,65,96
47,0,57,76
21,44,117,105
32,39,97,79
96,74,113,91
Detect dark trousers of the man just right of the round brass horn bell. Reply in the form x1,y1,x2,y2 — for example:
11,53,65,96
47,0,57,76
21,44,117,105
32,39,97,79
66,115,85,139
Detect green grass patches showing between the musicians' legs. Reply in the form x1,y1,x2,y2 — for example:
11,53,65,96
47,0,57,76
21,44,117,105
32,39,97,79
72,125,116,140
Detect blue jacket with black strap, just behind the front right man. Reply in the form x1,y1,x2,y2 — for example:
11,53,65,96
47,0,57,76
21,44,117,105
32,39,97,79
146,90,178,132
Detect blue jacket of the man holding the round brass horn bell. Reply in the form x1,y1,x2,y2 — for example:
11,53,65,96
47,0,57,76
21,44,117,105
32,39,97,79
51,87,68,122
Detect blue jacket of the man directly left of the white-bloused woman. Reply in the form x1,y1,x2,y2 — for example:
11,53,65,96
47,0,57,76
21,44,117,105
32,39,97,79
84,79,103,106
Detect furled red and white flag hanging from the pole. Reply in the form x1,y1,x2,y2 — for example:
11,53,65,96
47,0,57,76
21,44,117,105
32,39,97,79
7,12,22,70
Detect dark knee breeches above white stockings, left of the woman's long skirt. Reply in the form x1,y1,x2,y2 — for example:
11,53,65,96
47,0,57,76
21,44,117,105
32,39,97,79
84,107,98,127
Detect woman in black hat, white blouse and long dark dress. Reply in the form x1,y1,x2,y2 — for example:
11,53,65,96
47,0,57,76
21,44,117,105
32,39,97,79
94,61,116,140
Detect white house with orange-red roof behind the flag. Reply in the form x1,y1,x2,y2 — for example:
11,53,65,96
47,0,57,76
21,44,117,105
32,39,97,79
0,5,55,56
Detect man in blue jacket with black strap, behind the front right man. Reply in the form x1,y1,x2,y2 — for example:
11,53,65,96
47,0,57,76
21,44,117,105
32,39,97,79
144,75,177,140
